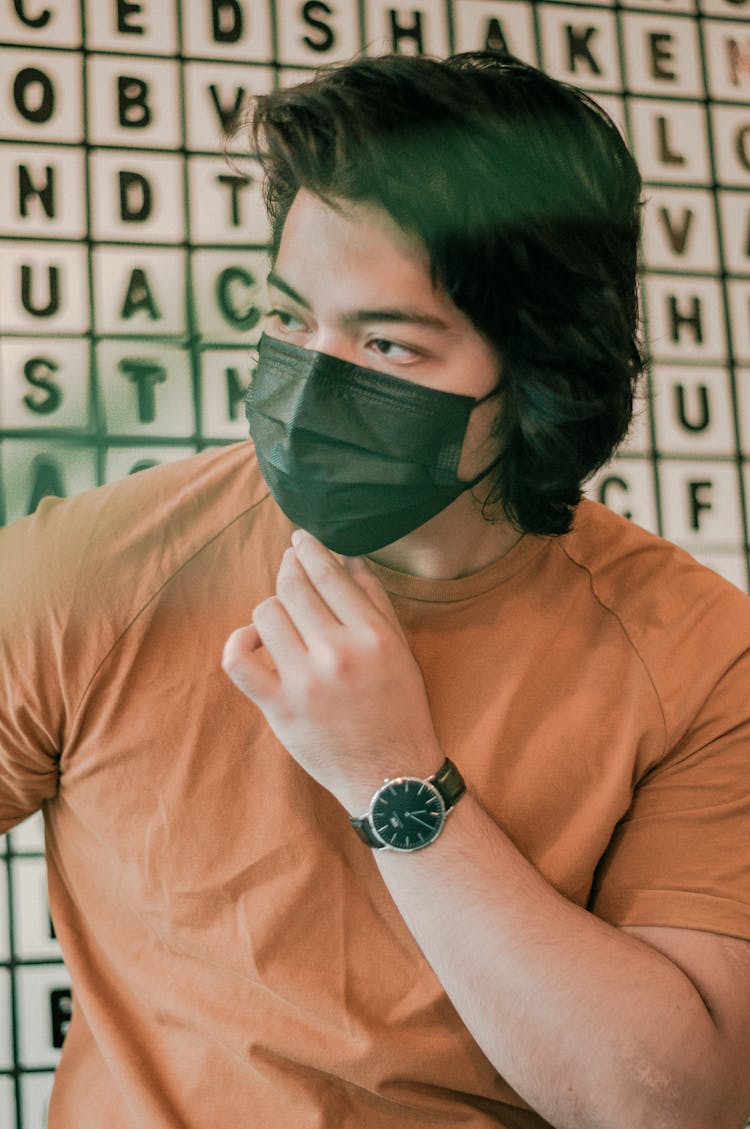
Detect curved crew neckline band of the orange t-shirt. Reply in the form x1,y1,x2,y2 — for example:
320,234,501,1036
366,533,551,604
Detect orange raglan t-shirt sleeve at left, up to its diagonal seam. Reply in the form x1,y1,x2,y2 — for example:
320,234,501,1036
0,443,268,833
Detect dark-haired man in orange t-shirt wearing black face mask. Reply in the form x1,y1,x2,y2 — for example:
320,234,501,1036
0,54,750,1129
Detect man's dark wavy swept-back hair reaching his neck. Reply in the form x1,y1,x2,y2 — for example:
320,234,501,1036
250,52,644,534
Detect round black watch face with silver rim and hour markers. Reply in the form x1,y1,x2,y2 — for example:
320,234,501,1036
369,777,445,850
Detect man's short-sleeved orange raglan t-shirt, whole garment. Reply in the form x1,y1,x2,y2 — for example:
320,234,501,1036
0,443,750,1129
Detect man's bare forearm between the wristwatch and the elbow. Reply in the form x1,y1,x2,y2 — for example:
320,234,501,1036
375,795,722,1129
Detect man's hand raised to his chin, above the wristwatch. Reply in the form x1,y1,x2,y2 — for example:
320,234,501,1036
221,531,443,815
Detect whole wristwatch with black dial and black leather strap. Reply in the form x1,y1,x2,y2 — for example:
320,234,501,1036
350,756,466,851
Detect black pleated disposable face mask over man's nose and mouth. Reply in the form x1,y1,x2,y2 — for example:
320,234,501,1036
245,336,498,557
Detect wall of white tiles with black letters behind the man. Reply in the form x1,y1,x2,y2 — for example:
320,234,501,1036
0,0,750,1129
